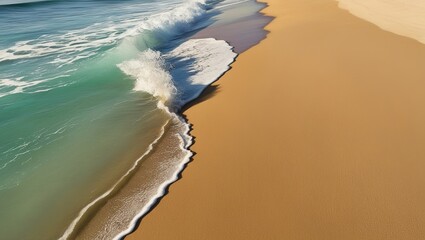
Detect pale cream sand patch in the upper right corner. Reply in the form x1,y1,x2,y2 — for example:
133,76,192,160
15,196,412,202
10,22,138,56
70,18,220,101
337,0,425,43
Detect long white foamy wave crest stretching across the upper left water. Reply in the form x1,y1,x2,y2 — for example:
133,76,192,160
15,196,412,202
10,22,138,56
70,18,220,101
0,0,212,66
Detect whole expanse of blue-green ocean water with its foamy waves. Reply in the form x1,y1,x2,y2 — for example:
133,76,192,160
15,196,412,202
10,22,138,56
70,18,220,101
0,0,264,240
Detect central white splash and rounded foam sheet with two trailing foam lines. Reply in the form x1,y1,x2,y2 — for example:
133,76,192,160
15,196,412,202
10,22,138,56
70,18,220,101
66,38,236,239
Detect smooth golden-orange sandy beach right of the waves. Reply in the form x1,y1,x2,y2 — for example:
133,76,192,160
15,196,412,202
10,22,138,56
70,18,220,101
126,0,425,240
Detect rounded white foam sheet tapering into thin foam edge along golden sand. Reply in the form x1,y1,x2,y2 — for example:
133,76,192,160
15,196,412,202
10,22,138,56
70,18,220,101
109,38,237,239
